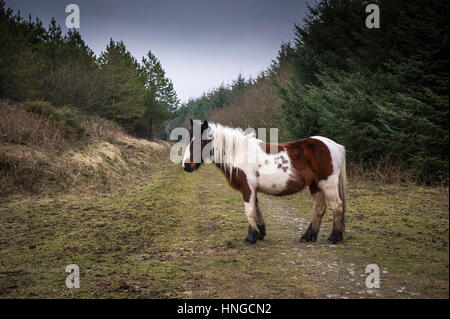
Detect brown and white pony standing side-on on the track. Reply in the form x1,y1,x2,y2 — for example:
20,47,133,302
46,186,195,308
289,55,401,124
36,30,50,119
182,119,346,244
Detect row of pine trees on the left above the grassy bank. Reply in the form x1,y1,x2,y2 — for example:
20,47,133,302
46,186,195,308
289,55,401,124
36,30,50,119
0,0,179,139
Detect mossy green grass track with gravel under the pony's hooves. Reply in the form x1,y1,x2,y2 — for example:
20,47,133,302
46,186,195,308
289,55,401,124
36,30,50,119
0,164,449,298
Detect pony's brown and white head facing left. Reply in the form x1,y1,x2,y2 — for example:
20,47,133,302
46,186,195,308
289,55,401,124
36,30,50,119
181,119,211,173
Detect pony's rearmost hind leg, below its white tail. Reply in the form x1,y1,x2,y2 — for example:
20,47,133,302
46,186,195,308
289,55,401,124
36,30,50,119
321,179,345,244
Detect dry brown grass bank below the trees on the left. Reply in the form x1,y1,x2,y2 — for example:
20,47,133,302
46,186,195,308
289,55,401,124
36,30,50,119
0,101,169,196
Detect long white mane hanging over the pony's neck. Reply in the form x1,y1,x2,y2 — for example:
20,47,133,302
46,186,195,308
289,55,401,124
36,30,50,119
208,122,255,175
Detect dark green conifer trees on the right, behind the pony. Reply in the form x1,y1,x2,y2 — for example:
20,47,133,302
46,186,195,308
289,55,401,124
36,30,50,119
171,0,449,182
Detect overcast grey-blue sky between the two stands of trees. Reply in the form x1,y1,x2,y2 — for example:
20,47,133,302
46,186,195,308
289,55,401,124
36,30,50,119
6,0,306,101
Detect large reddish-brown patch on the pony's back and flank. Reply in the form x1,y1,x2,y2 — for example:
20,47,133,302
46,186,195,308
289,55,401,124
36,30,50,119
260,138,333,196
